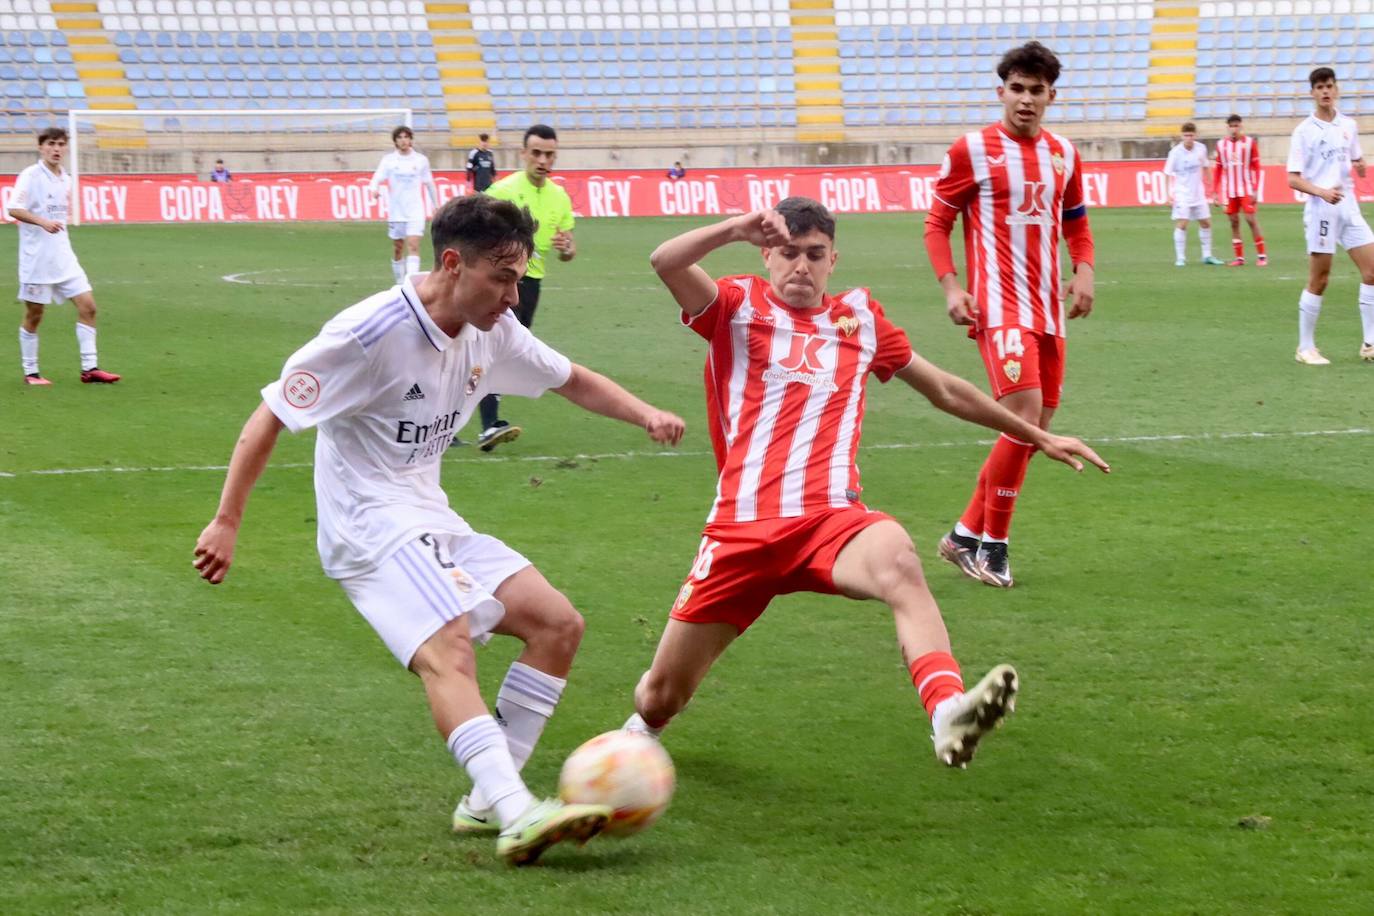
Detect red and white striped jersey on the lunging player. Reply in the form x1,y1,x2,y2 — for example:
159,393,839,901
683,276,912,522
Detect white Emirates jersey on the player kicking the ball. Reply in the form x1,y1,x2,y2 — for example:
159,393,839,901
262,275,572,578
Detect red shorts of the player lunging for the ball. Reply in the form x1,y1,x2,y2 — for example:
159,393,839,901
671,505,892,633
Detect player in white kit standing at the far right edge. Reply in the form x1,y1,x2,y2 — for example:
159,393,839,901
1287,67,1374,365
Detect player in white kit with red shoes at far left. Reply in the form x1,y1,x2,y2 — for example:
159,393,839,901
10,128,120,385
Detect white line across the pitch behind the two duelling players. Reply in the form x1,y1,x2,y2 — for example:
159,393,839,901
0,427,1374,478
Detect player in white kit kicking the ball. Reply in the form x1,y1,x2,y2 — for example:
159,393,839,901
195,195,683,865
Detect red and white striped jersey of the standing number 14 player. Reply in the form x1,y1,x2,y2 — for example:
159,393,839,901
932,124,1085,336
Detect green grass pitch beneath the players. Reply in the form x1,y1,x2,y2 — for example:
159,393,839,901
0,207,1374,913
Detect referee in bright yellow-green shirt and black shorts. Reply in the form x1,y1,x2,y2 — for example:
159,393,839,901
477,124,577,452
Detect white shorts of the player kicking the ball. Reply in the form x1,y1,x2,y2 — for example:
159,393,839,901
339,533,529,667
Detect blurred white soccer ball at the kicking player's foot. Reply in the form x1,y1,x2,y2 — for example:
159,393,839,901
558,731,677,836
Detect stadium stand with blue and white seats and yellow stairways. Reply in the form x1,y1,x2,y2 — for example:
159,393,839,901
8,0,1374,159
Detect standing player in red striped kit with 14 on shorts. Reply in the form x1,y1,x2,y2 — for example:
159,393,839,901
925,41,1092,588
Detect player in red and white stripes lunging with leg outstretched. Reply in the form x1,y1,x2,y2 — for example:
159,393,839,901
625,198,1106,766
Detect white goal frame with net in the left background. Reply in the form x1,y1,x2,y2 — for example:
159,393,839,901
67,107,412,222
